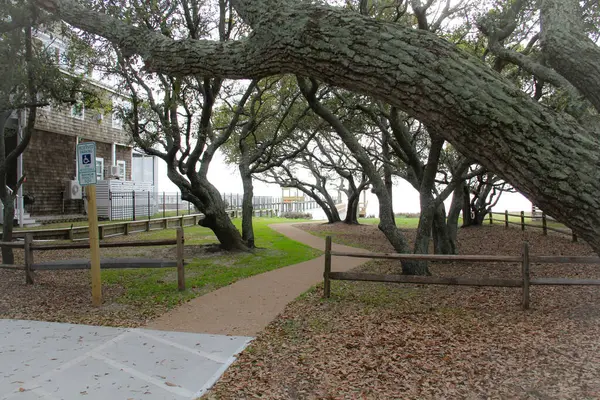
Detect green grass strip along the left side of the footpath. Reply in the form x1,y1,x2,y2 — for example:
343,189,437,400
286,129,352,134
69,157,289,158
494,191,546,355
102,218,321,308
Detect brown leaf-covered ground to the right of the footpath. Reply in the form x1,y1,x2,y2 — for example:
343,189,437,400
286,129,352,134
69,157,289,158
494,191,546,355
207,224,600,399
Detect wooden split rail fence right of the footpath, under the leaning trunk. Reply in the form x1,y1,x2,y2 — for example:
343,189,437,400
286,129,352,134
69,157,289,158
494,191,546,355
323,236,600,309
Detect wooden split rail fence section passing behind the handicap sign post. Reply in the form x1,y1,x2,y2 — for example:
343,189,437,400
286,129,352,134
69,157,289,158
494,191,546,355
0,227,185,290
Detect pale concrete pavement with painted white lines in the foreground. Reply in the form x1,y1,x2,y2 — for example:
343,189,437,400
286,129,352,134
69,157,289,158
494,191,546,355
0,319,252,400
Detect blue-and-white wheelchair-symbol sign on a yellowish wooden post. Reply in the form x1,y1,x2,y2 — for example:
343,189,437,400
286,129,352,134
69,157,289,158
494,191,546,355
77,142,102,307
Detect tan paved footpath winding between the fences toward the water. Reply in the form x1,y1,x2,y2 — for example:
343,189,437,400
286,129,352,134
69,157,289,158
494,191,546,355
147,224,367,336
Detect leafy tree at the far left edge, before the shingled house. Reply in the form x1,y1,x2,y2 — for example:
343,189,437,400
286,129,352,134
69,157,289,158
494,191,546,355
0,0,84,264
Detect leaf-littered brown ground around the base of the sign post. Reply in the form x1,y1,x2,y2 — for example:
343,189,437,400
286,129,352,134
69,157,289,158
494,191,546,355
0,238,231,327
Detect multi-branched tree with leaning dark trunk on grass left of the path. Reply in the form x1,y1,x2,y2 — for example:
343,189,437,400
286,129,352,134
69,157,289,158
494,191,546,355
104,0,255,250
